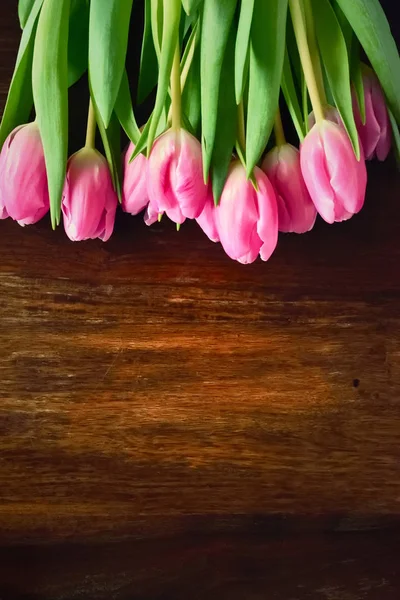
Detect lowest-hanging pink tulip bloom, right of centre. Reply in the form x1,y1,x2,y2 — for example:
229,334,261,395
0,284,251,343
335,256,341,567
215,160,278,264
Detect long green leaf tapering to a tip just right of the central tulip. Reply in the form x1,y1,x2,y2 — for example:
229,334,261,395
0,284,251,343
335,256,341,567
200,0,237,181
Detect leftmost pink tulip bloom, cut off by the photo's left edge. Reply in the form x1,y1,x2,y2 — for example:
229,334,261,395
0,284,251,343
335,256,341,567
0,123,49,225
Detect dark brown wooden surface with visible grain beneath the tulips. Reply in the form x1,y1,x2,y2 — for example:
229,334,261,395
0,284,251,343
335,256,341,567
0,2,400,600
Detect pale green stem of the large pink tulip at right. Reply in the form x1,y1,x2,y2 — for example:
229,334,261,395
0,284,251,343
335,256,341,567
289,0,325,123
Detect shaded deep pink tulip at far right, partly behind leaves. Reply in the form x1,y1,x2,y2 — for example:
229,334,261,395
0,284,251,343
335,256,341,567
353,71,392,160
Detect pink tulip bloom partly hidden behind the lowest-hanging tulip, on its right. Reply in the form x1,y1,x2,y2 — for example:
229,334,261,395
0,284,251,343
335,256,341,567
261,144,317,233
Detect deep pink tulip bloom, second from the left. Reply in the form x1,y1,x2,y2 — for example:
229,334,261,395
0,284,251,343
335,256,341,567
62,148,118,242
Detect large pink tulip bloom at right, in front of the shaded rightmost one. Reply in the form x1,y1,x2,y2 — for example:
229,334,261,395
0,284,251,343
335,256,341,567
300,119,367,223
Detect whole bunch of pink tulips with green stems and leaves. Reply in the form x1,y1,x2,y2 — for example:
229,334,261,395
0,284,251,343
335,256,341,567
0,0,400,263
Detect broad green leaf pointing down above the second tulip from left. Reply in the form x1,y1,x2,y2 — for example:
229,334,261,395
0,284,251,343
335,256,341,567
89,0,132,127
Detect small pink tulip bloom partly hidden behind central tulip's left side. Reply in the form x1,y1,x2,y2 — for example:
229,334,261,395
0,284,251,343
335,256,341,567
121,142,149,215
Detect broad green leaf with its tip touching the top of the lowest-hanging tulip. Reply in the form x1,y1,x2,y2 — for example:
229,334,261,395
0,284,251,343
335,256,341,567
246,0,288,177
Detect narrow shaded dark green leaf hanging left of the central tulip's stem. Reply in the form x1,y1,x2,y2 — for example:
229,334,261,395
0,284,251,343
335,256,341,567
137,0,158,104
